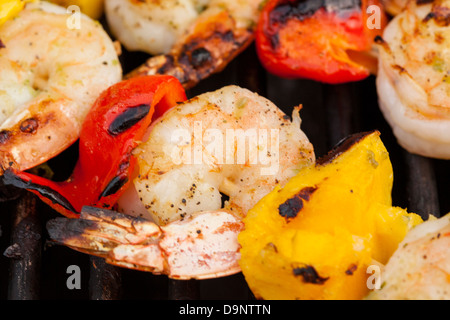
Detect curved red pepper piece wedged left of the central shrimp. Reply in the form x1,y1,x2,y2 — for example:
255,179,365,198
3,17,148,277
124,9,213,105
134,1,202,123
3,75,186,218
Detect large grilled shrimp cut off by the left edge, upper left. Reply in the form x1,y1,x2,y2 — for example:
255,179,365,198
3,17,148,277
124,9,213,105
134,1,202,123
0,2,122,172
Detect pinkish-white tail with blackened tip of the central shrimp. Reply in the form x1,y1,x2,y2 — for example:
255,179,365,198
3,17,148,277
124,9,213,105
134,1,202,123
47,207,243,279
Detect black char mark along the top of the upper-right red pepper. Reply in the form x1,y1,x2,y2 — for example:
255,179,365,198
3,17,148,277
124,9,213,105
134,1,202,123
269,0,361,25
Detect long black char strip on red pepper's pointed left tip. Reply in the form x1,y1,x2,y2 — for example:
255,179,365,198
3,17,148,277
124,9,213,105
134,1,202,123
2,169,78,214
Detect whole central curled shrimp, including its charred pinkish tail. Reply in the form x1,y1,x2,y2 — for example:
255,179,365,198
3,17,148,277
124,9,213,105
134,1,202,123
44,86,315,279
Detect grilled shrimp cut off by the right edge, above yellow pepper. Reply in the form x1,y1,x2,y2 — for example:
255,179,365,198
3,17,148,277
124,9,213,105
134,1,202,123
376,0,450,159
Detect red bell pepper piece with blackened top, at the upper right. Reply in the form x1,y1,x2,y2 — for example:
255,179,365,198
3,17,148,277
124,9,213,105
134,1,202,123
255,0,386,84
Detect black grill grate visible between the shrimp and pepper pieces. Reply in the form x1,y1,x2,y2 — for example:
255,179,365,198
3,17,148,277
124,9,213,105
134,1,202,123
0,42,450,300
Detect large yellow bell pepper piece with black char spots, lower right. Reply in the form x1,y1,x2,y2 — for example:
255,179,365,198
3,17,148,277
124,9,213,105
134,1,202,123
238,132,422,300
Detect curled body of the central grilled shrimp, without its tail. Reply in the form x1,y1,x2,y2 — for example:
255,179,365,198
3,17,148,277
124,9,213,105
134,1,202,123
119,86,315,225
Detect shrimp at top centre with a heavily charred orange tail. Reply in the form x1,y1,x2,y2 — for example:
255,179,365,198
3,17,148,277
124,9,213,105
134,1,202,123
105,0,262,88
